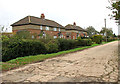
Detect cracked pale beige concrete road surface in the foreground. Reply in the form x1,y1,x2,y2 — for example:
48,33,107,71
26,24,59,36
1,41,118,82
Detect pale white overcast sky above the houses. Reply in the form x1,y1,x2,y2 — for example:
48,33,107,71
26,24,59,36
0,0,118,35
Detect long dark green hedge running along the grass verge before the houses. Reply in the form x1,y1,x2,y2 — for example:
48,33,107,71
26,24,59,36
2,37,92,62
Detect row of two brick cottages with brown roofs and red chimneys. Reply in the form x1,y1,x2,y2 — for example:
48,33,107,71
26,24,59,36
11,14,87,39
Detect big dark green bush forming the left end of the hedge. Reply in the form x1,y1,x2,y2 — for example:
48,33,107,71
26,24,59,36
2,40,47,61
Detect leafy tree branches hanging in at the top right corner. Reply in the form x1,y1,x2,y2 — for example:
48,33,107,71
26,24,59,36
107,0,120,20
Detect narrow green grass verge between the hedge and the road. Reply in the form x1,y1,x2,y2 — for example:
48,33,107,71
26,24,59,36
0,42,115,71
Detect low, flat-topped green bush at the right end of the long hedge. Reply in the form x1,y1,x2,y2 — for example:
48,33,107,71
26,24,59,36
77,39,92,46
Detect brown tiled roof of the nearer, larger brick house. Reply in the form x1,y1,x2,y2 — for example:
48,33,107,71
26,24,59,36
11,16,64,28
